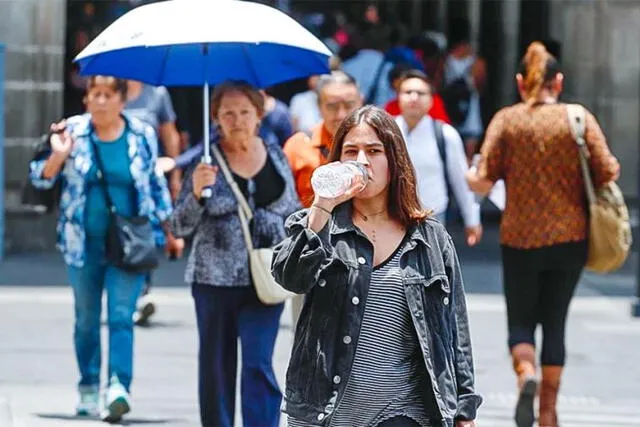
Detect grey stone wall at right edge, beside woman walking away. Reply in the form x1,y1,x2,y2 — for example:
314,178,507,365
551,0,640,198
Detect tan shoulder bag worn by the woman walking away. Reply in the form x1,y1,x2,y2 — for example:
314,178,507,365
567,105,631,273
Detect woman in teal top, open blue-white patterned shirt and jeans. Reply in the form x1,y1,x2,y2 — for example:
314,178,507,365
30,76,171,422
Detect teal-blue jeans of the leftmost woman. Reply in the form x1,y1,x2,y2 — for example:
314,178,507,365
68,241,144,391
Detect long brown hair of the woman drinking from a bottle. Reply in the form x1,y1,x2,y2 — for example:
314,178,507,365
329,105,429,227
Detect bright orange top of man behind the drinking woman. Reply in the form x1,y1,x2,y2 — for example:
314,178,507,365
284,123,333,208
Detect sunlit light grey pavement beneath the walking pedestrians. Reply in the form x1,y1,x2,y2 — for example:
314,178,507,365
0,222,640,427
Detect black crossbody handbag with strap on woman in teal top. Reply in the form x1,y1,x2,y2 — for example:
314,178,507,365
91,138,158,273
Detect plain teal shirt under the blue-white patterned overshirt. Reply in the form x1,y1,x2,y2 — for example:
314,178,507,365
85,128,137,237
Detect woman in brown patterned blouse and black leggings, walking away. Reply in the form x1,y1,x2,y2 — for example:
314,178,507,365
467,42,619,427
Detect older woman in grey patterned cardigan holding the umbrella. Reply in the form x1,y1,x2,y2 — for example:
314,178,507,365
172,81,299,427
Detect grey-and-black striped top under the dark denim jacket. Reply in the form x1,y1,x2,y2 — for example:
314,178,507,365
288,241,431,427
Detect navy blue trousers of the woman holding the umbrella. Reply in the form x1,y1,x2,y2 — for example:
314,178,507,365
191,284,284,427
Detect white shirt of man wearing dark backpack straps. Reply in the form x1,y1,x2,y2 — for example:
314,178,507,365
396,116,480,227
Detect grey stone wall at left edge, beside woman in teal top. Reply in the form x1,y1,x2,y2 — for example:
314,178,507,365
0,0,66,251
